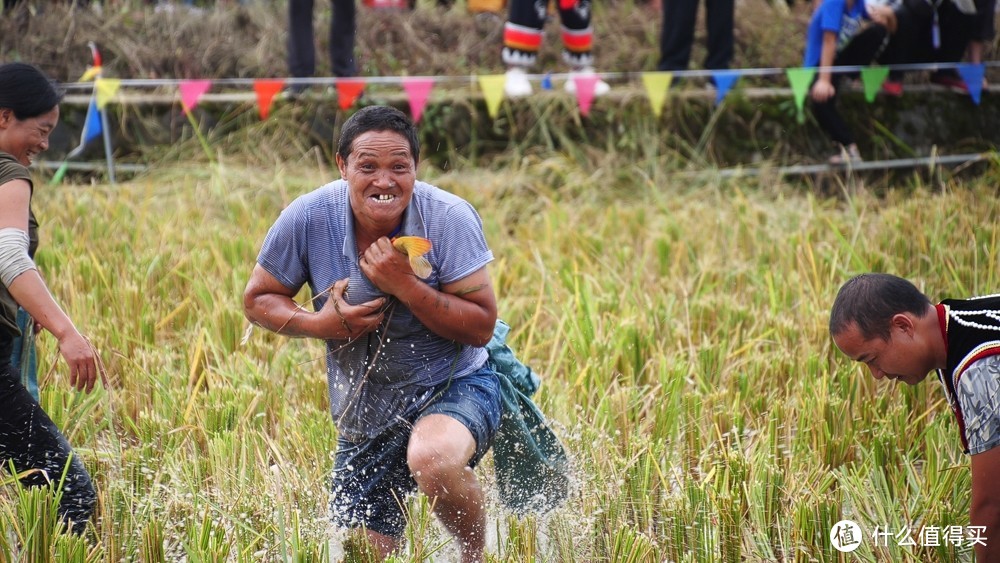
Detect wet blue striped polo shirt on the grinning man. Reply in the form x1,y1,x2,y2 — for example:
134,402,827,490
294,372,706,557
257,180,493,441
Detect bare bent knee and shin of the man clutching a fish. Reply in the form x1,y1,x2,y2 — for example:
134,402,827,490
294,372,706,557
406,414,486,563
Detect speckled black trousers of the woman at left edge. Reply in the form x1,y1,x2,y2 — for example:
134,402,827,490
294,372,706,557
0,366,97,534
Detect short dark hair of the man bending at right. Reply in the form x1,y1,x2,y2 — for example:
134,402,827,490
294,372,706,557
830,274,931,340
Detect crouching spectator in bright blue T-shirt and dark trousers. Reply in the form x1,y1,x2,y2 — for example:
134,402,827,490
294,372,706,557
802,0,896,164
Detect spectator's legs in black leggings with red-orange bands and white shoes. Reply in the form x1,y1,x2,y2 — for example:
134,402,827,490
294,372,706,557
501,0,611,98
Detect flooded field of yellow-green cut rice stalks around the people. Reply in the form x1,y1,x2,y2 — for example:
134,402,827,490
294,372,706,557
0,154,1000,562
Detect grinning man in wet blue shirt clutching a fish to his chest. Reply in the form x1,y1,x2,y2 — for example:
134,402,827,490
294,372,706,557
244,106,500,562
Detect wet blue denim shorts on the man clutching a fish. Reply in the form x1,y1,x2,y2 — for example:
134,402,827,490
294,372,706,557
330,363,500,538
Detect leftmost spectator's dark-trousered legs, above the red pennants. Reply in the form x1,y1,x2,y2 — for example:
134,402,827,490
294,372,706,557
288,0,357,92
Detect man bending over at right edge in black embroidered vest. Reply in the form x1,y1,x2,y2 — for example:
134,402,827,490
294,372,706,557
830,274,1000,561
